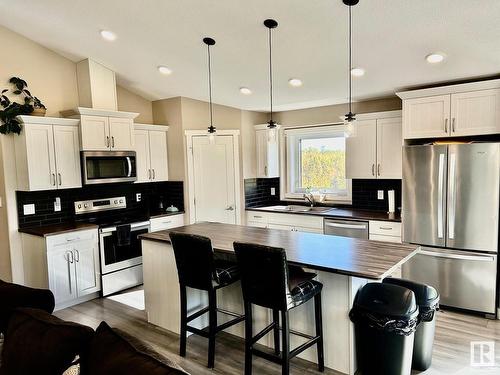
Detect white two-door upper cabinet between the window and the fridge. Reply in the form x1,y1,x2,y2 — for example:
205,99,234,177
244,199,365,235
346,111,403,179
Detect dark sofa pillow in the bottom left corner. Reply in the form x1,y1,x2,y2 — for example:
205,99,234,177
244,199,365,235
0,308,94,375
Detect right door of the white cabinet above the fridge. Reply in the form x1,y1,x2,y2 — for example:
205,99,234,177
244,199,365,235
451,89,500,136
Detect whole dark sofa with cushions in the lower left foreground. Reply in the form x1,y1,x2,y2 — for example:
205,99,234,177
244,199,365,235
0,280,187,375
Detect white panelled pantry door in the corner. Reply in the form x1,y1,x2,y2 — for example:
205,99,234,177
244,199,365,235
193,135,236,224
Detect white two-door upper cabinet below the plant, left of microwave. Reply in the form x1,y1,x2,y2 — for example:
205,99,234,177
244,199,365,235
14,116,82,191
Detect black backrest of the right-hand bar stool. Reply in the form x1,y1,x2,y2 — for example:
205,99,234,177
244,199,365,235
234,242,290,311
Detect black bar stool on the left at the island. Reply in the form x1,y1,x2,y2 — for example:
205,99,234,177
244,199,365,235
170,232,245,368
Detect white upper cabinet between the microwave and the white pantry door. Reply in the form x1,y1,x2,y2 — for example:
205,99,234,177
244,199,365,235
134,124,168,182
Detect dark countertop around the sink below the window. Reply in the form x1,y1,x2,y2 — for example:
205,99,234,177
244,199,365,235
246,206,401,222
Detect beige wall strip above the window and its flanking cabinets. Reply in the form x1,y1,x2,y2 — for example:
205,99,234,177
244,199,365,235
276,96,401,126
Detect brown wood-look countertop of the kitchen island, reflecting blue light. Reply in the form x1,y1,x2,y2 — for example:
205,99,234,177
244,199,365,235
139,223,419,280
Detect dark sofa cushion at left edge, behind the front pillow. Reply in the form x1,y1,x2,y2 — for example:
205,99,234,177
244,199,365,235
0,280,54,334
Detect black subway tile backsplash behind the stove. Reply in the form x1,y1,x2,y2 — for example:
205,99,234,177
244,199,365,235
16,181,184,228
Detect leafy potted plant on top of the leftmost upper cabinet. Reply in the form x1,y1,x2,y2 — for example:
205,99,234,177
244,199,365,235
0,77,47,134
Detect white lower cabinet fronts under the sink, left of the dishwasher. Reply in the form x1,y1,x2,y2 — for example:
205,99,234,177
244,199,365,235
247,211,323,233
